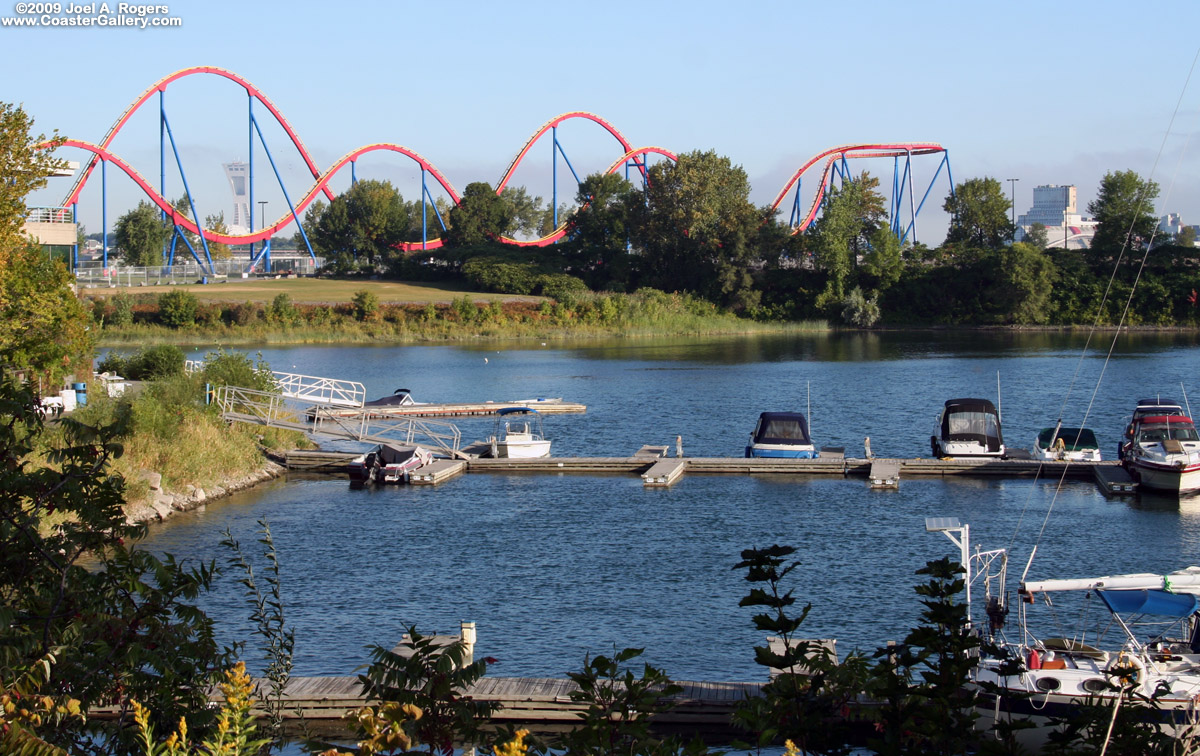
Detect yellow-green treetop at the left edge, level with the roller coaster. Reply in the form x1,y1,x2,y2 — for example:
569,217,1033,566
0,102,65,268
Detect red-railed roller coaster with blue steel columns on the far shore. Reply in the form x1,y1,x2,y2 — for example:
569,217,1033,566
41,66,954,271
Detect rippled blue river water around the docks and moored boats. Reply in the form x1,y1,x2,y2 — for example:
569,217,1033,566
146,332,1200,680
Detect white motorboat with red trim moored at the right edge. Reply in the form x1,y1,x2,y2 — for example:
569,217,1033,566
1124,415,1200,493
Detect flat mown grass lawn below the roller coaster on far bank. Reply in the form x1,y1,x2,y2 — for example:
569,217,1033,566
79,278,544,305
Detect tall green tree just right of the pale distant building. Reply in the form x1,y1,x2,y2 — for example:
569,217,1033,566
1087,170,1158,256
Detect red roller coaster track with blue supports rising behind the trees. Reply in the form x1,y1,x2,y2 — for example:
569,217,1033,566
30,66,954,278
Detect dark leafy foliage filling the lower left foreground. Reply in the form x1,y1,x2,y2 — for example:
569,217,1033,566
0,382,228,754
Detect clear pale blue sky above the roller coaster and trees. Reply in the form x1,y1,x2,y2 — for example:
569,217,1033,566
9,0,1200,244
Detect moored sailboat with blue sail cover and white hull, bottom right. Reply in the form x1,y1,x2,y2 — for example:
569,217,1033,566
925,517,1200,750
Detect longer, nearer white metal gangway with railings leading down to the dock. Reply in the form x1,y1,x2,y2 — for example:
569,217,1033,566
216,386,467,458
